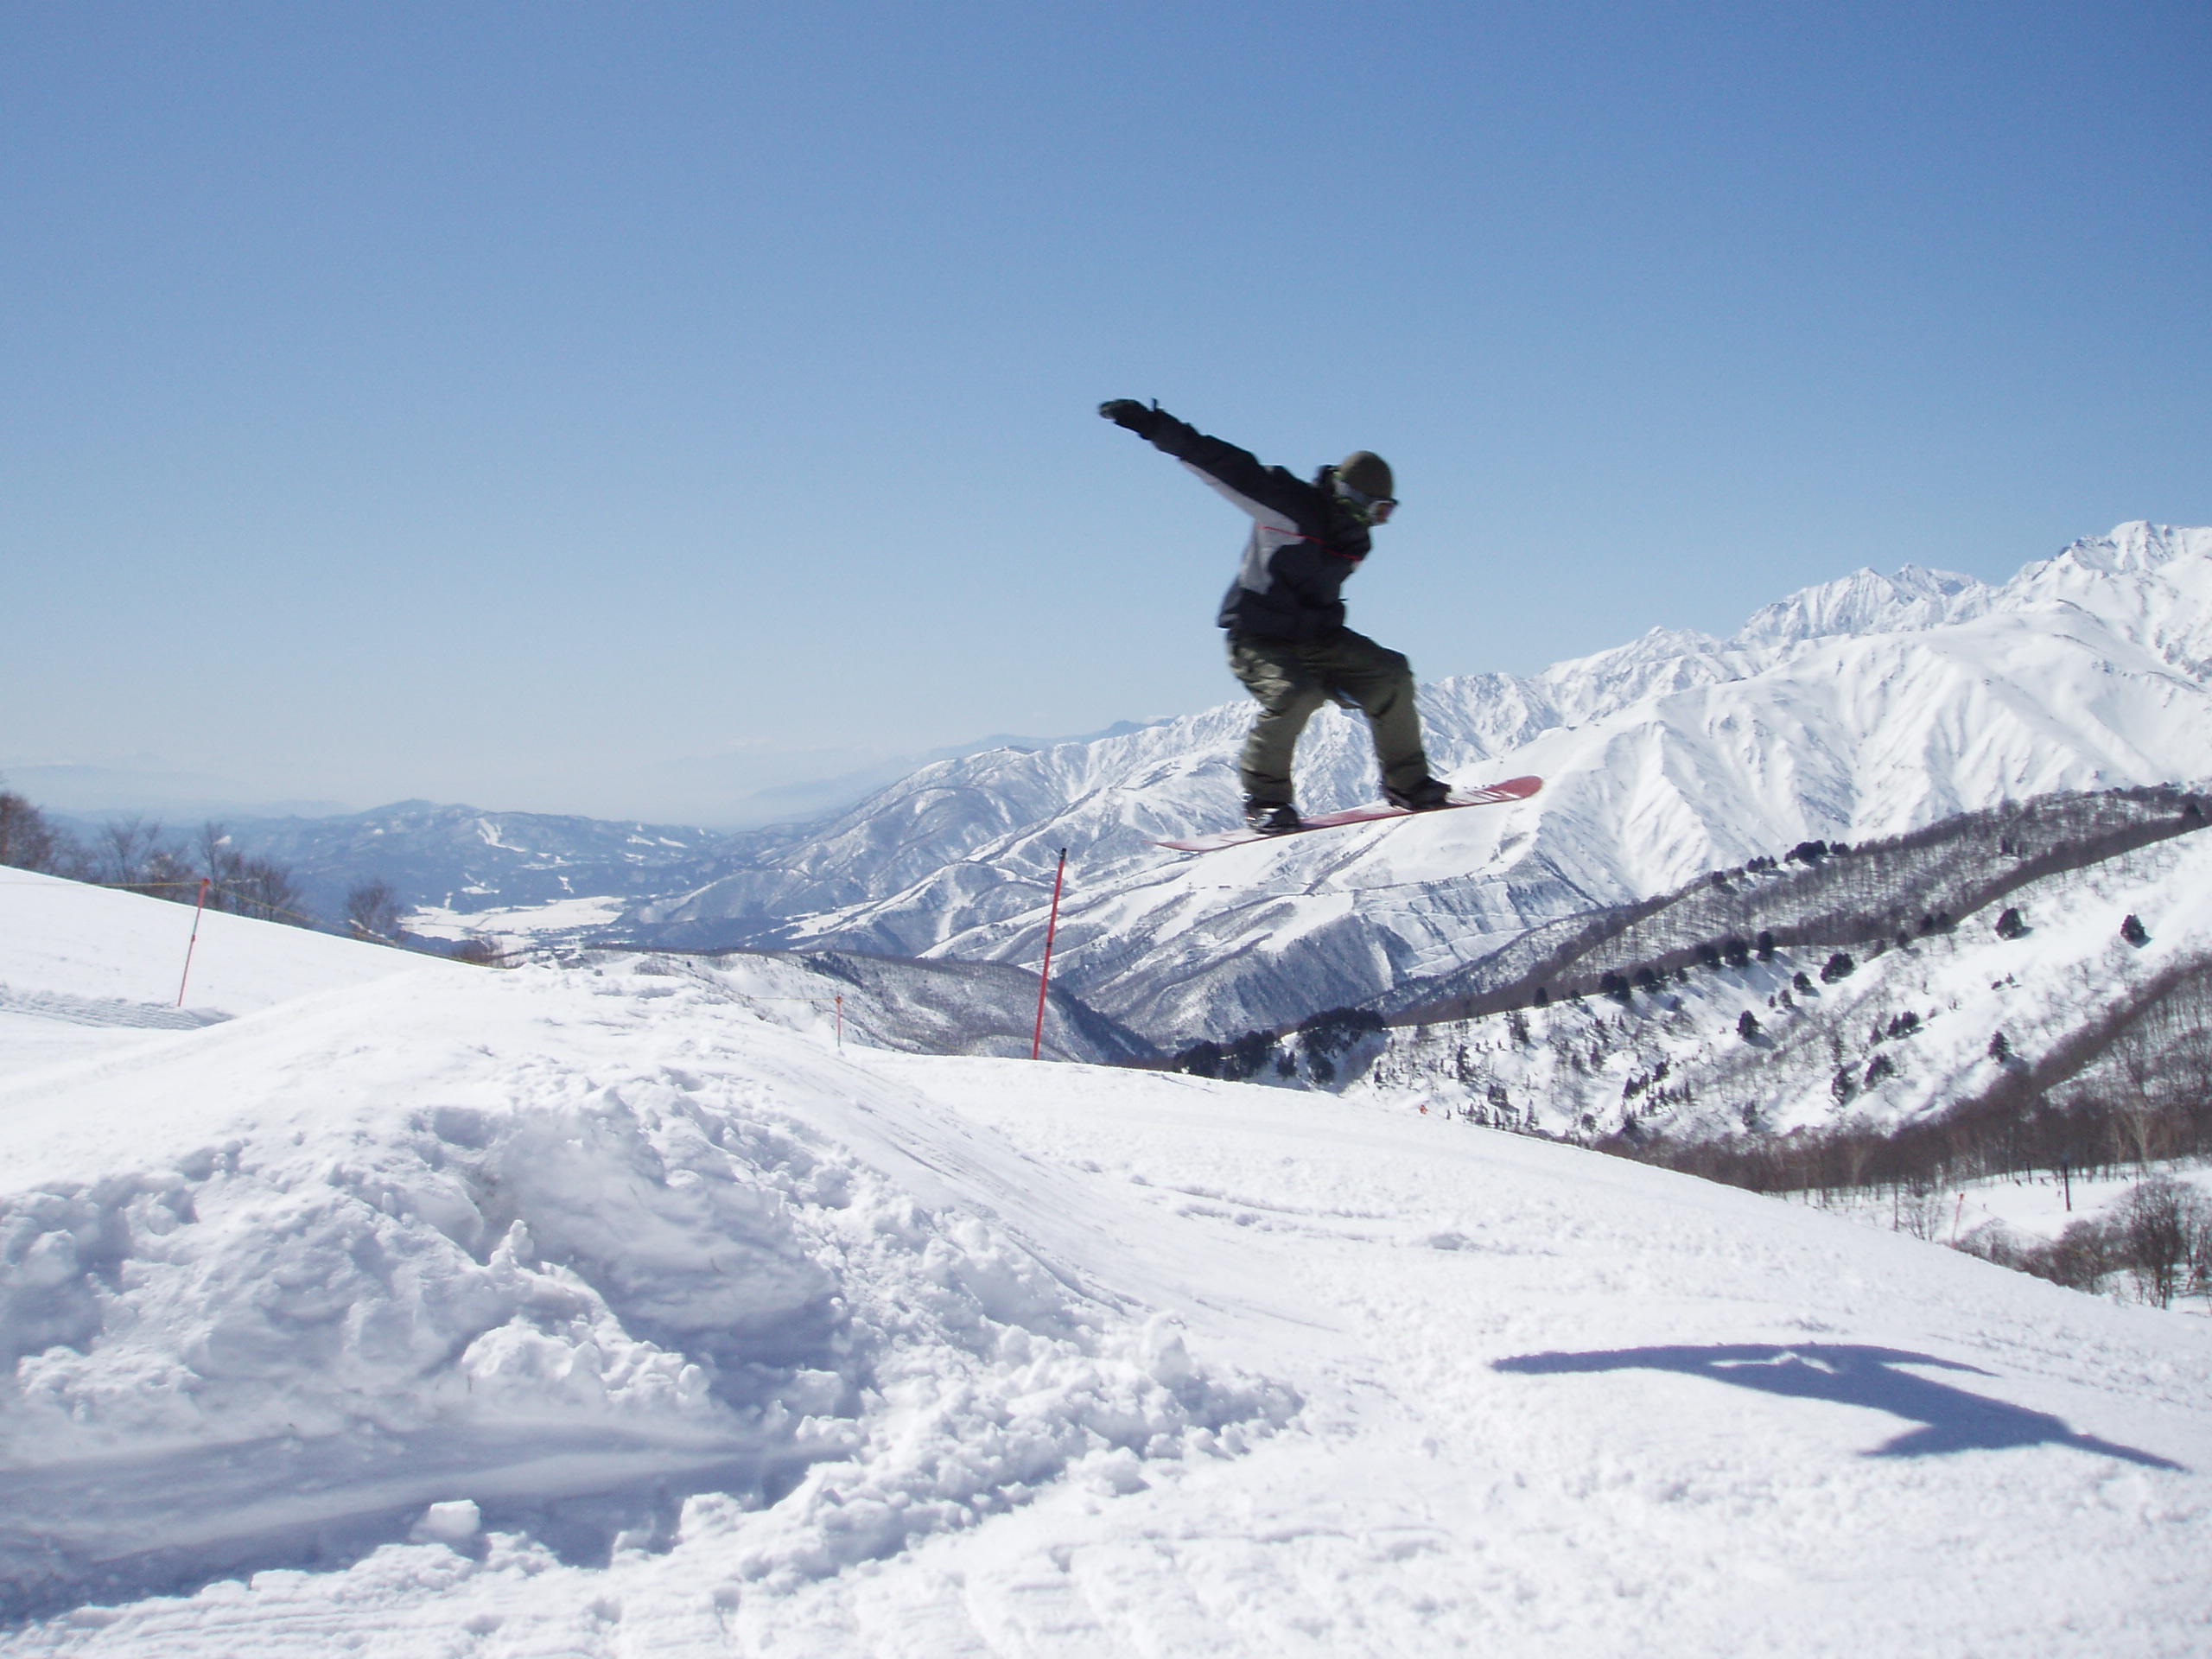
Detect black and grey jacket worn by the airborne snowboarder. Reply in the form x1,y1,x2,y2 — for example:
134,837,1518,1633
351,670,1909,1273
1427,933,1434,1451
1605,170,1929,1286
1144,411,1367,644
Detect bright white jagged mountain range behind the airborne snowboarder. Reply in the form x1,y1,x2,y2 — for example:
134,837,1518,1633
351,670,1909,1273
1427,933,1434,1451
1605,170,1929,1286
624,524,2212,1046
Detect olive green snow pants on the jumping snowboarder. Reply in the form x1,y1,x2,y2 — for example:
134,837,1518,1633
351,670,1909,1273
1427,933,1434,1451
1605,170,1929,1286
1230,628,1429,805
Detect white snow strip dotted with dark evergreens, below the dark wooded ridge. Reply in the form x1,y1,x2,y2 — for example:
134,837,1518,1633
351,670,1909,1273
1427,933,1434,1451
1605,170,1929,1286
1358,814,2212,1139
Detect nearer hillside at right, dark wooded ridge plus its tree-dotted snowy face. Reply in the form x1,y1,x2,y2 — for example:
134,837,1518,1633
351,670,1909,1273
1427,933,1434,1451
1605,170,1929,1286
1190,790,2212,1161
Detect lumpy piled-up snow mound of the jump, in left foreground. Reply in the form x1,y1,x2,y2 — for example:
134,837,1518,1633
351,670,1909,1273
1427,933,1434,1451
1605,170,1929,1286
0,971,1292,1611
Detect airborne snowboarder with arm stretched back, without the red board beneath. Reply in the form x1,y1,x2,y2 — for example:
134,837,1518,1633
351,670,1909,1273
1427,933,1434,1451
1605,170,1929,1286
1099,398,1451,834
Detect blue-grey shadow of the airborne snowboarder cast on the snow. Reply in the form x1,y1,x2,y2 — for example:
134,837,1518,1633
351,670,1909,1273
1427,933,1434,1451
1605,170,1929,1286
1491,1343,2183,1469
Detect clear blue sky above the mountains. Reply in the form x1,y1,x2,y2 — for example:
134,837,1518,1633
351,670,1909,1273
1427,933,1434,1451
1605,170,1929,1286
0,0,2212,817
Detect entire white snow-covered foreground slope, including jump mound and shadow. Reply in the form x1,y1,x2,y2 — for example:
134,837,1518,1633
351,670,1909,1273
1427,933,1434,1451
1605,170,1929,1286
0,885,2212,1659
